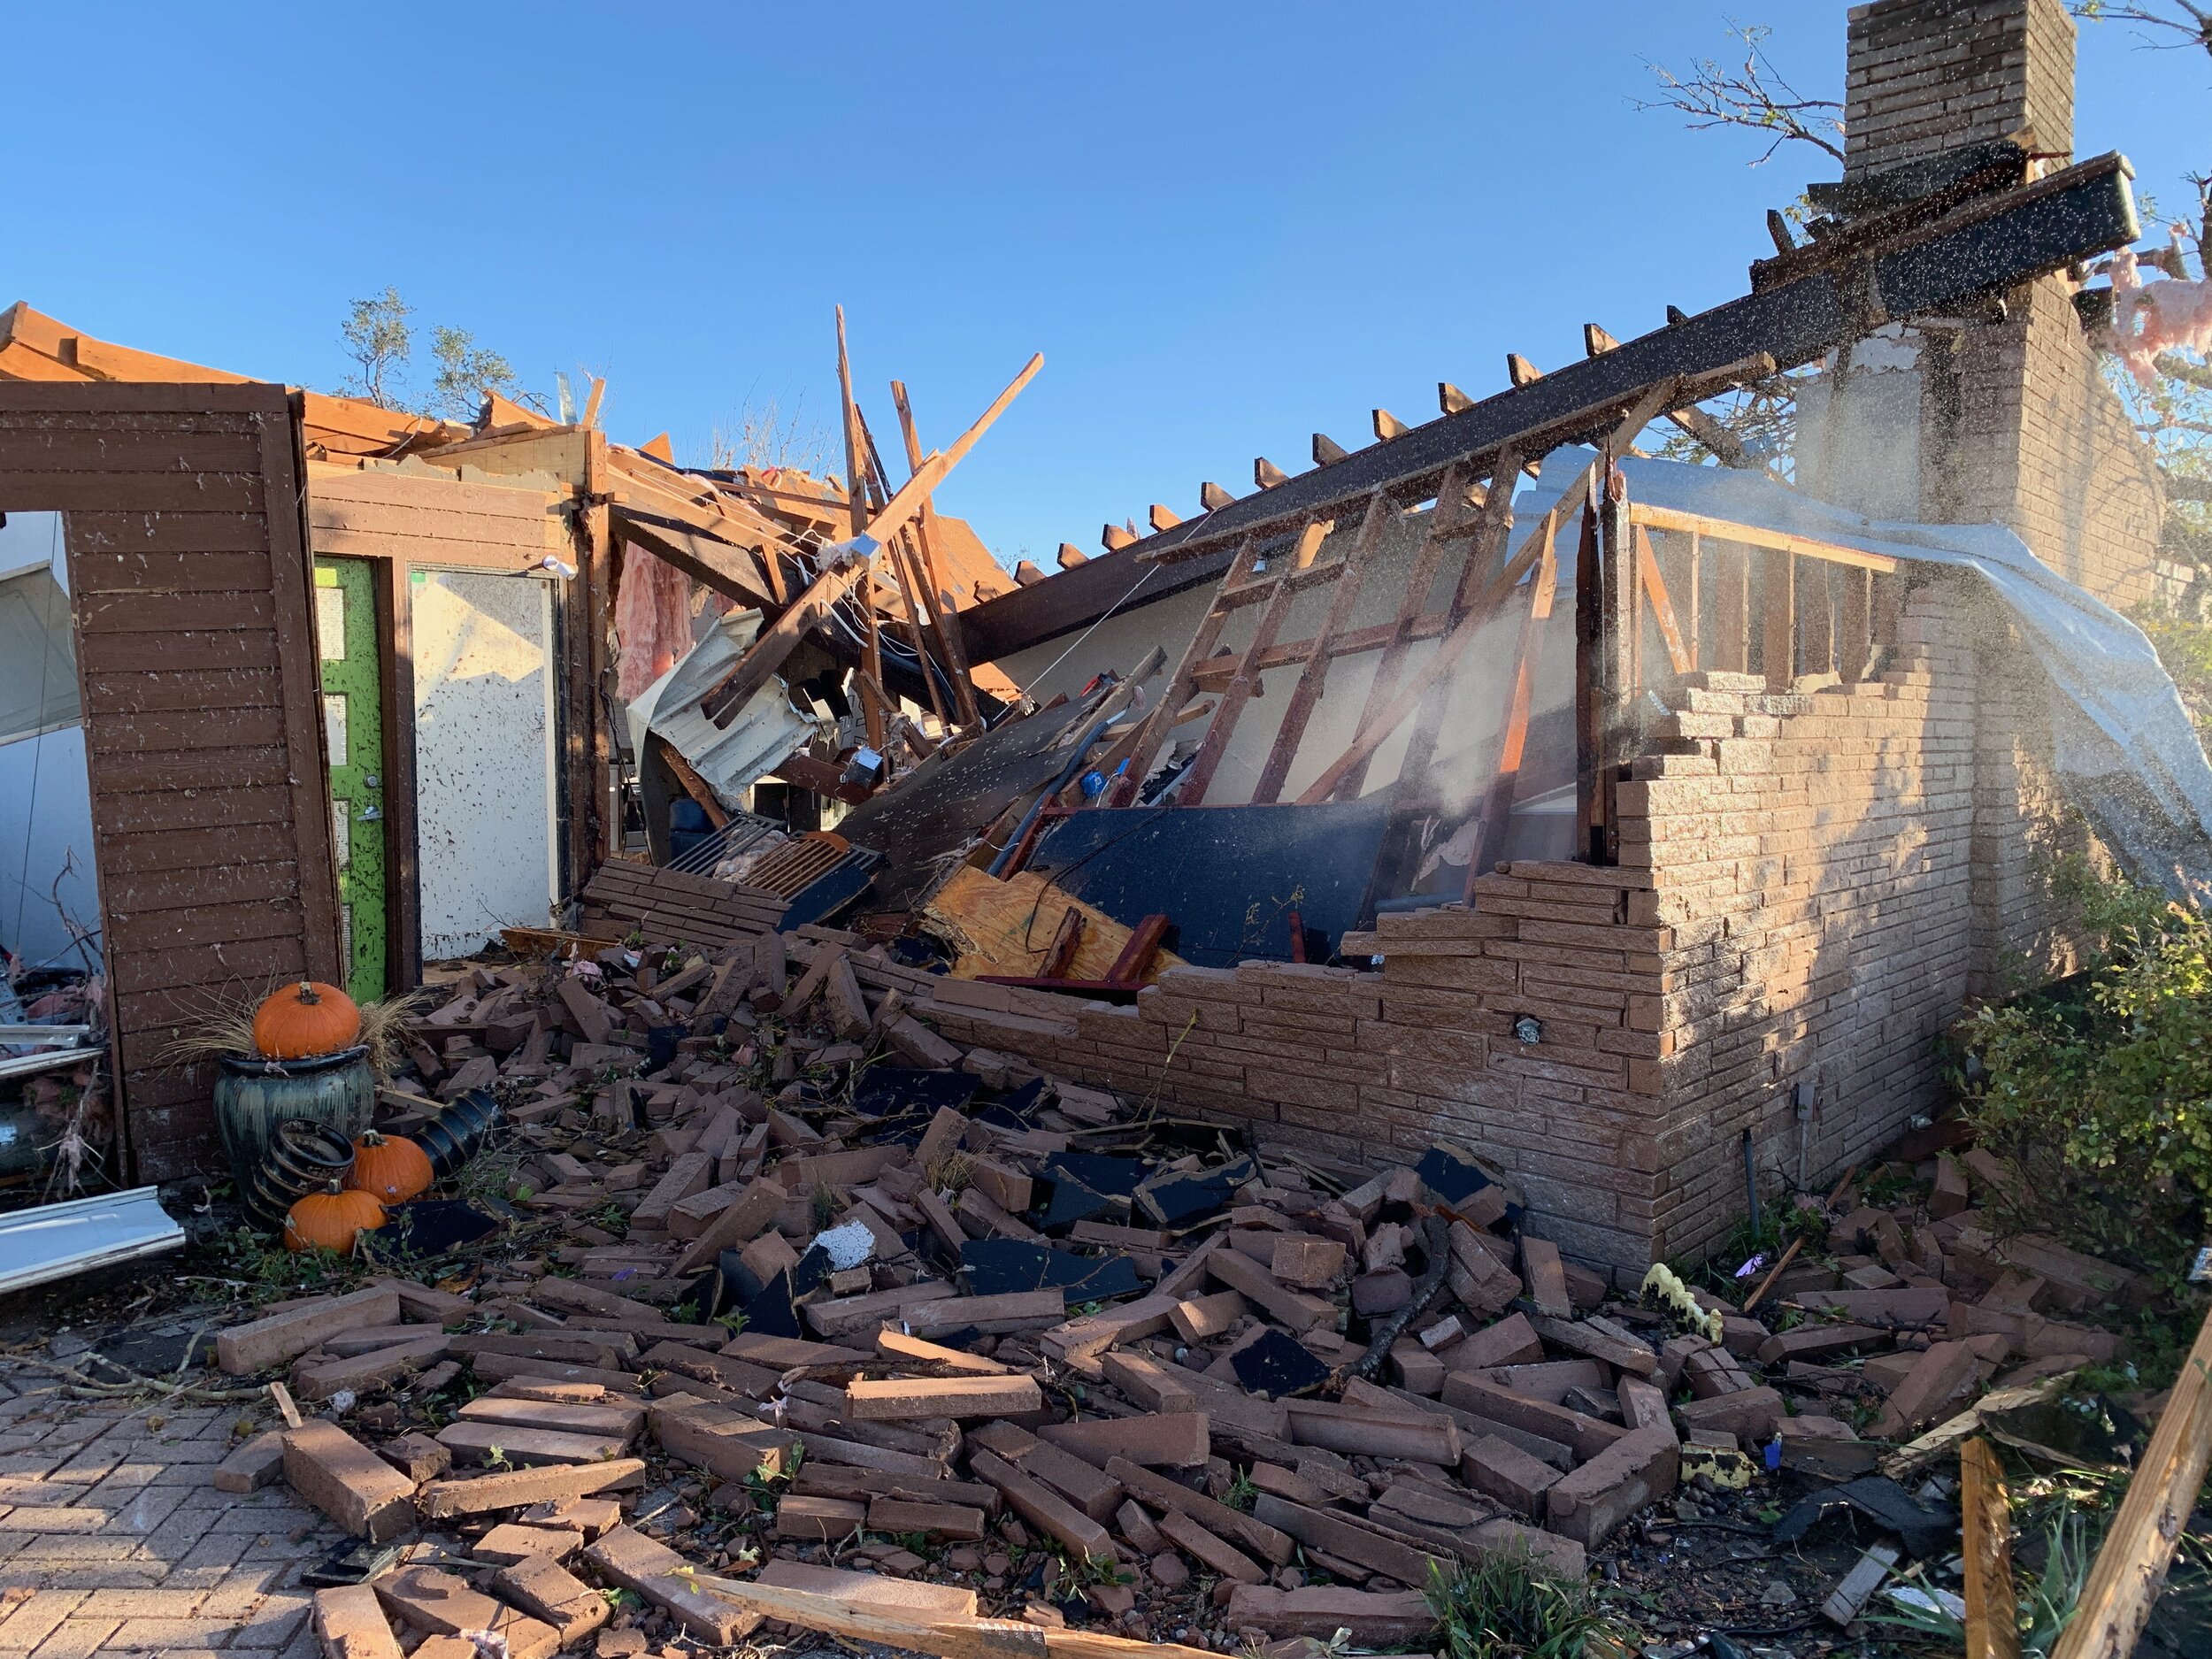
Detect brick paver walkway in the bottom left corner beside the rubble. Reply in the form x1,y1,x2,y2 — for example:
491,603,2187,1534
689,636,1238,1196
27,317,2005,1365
0,1371,341,1659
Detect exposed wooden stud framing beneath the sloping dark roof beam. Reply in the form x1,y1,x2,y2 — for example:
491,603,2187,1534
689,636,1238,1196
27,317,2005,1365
1110,365,1898,876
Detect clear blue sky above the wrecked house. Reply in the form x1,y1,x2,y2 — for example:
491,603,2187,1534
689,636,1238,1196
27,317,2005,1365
0,0,2212,566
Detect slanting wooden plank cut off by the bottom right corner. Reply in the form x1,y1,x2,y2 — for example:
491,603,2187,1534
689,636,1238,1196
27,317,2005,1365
2051,1314,2212,1659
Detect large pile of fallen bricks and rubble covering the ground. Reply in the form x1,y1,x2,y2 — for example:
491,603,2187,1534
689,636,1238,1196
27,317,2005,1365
125,929,2194,1655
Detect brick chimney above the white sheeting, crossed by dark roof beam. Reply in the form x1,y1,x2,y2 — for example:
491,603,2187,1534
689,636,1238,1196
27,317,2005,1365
1799,0,2162,606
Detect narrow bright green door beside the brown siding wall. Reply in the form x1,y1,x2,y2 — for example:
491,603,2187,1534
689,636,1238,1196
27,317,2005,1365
314,560,388,1002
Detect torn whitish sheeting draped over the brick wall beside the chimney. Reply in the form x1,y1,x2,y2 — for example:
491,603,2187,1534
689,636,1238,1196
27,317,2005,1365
1513,456,2212,901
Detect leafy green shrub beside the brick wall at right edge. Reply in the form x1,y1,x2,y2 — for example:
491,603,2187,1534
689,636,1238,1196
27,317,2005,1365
1955,858,2212,1268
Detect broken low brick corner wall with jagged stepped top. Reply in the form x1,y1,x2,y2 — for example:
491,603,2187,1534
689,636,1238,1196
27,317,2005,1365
923,578,2070,1272
